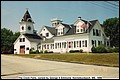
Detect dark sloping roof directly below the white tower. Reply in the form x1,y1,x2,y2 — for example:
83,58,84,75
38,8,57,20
23,34,42,42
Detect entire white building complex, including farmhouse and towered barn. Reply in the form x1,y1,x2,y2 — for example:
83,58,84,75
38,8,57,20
14,10,110,54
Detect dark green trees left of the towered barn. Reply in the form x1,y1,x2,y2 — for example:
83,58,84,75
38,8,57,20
1,28,20,53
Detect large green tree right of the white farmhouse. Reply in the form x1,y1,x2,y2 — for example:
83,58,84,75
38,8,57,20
103,17,119,47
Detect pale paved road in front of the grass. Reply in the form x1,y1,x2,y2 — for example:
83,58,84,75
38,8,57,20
1,55,119,79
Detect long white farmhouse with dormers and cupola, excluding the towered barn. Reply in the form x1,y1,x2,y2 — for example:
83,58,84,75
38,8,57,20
39,17,110,53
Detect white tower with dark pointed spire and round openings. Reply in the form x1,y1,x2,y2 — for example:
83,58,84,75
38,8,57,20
19,9,35,34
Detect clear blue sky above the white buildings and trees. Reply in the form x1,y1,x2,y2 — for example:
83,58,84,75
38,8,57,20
1,1,119,32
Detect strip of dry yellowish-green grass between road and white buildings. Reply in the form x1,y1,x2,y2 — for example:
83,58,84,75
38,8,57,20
3,53,119,67
